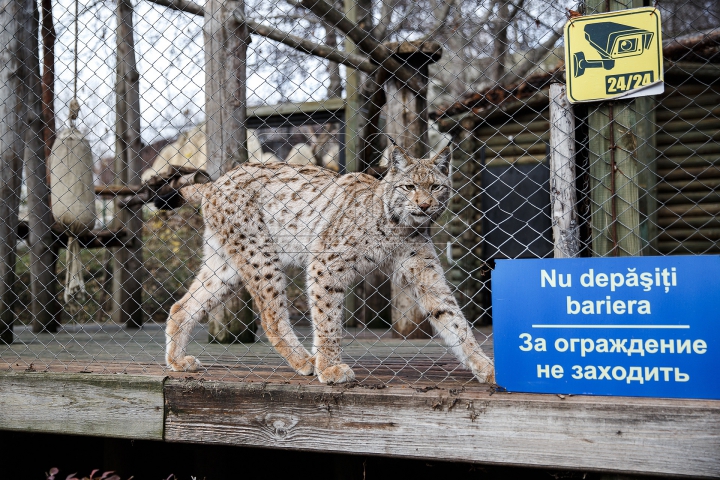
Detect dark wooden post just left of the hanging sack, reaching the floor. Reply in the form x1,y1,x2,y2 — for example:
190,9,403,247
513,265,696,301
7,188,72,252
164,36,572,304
24,0,63,333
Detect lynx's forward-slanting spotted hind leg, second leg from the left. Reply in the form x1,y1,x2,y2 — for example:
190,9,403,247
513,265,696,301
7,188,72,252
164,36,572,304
240,249,315,375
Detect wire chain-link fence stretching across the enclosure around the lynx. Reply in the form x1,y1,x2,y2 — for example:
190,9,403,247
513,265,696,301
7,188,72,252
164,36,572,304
0,0,720,388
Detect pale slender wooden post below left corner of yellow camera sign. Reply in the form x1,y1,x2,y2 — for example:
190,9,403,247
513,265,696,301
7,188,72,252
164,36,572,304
550,83,580,258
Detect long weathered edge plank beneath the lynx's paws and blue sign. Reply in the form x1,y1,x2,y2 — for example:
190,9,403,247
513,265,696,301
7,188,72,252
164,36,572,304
165,380,720,477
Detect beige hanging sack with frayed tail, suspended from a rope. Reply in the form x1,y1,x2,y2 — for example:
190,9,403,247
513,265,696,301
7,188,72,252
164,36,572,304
50,127,96,303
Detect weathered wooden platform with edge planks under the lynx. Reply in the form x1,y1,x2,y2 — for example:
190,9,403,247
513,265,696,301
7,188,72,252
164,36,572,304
0,326,720,478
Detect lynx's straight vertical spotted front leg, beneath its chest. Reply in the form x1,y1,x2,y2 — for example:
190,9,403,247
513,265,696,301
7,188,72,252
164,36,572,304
308,262,355,383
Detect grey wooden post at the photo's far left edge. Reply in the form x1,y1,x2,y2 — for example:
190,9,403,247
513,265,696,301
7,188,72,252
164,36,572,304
0,0,33,343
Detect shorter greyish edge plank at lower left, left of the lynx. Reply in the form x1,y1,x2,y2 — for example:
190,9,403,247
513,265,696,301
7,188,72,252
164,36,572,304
0,372,164,440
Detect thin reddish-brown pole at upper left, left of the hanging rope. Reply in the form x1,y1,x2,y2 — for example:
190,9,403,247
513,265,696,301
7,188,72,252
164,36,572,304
41,0,57,160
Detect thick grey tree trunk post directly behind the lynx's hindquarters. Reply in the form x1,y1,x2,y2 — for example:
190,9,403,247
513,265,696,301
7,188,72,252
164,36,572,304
204,0,257,343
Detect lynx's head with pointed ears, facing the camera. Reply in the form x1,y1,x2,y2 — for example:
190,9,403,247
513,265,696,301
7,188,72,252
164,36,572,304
383,147,450,227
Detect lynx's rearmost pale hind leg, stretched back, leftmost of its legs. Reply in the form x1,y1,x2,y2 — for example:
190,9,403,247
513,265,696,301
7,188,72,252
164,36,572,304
165,262,239,372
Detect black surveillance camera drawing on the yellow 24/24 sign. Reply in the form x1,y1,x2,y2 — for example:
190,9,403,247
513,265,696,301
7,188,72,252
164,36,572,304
573,22,654,77
